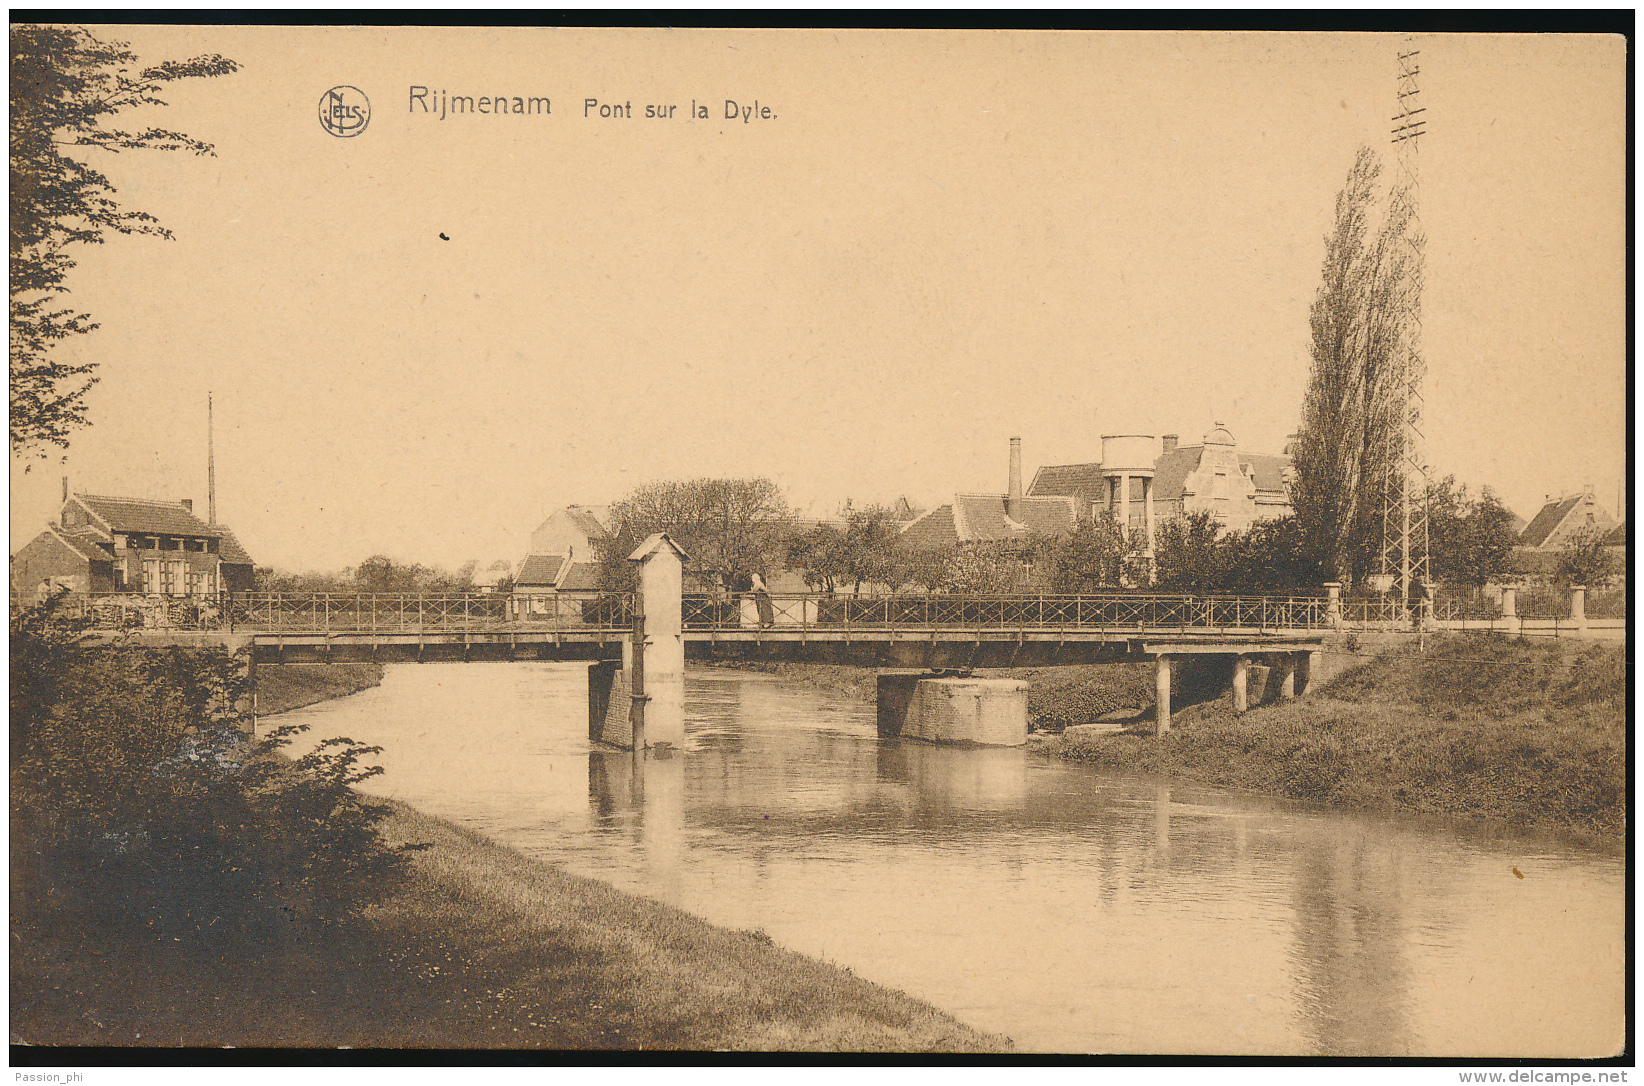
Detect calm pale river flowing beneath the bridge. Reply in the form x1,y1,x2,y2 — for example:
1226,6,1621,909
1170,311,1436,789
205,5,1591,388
281,664,1626,1058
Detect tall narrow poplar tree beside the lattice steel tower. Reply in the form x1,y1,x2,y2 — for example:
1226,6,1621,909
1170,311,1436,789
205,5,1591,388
1294,148,1422,583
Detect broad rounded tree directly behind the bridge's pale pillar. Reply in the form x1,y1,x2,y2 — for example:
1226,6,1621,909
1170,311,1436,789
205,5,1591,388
600,478,792,591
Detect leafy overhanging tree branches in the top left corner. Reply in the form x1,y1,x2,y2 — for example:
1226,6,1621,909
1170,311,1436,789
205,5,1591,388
10,23,238,457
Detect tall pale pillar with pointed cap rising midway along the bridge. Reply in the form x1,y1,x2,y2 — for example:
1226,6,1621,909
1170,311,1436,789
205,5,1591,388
628,532,687,751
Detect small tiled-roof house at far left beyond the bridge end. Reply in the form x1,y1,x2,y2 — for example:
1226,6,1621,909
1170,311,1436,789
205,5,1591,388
12,493,253,598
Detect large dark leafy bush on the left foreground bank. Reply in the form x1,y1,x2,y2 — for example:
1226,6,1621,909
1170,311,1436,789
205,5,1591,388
10,600,417,928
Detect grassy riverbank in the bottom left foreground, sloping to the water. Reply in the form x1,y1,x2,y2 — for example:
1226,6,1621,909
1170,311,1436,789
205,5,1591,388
10,805,1009,1051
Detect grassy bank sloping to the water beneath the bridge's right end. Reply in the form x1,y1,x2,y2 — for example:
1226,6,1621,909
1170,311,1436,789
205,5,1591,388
1046,636,1628,841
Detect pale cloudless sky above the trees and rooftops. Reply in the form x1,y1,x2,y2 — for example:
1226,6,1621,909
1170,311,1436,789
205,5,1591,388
12,26,1629,570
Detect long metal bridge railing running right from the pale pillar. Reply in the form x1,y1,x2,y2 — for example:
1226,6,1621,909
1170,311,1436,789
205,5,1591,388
682,593,1330,633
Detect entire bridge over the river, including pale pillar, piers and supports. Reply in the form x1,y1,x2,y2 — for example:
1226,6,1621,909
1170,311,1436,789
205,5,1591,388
186,536,1340,751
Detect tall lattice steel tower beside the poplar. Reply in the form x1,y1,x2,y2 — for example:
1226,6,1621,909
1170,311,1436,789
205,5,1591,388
1381,43,1432,611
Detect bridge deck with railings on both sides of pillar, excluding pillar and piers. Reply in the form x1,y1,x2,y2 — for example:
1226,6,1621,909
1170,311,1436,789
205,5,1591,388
220,593,1333,669
